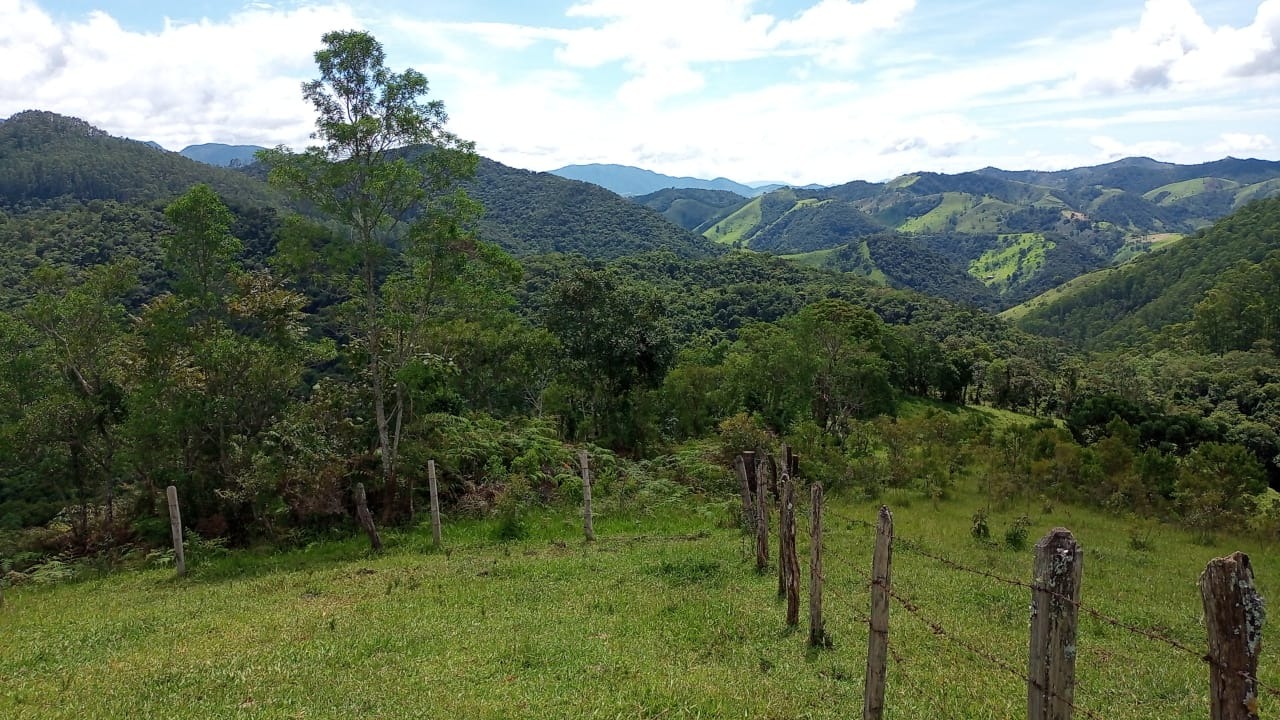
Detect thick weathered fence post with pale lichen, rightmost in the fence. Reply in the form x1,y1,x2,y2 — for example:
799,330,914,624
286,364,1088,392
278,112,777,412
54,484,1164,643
1199,552,1266,720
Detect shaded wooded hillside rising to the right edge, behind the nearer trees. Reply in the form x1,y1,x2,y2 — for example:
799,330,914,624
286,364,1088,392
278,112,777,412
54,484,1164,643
1012,197,1280,348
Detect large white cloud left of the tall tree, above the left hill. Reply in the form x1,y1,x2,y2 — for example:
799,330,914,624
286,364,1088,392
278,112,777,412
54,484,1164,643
0,0,358,149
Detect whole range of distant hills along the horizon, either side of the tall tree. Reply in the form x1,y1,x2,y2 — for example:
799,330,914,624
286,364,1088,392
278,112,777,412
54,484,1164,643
0,106,1280,327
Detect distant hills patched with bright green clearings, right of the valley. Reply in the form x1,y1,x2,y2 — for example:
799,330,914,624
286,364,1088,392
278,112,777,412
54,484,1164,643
698,159,1280,307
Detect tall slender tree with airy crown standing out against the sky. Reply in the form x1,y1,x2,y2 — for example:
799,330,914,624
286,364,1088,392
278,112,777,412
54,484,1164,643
260,31,479,515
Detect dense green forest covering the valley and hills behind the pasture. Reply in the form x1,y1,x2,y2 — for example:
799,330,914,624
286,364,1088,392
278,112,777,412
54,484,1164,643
0,33,1280,566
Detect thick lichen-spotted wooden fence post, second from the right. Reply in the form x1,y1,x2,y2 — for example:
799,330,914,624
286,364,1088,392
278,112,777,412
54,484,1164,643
1027,528,1084,720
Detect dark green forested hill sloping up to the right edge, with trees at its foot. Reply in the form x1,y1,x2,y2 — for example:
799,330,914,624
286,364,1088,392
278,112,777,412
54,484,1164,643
1018,197,1280,351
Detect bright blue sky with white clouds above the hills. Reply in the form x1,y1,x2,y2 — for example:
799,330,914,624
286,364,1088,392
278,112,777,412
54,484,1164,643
0,0,1280,184
